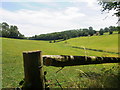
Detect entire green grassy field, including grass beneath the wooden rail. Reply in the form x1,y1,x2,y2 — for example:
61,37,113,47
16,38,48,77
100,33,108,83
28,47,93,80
0,34,118,88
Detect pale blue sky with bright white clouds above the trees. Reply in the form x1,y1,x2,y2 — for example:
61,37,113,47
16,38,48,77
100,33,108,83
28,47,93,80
0,0,118,37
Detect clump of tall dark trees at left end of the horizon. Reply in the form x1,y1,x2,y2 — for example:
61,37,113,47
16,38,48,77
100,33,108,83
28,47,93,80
0,22,25,39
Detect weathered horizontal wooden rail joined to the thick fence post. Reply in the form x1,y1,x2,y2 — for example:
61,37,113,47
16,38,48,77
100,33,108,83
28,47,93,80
42,55,120,67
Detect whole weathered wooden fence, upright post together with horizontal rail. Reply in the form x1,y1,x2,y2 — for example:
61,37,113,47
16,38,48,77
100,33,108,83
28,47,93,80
23,50,120,90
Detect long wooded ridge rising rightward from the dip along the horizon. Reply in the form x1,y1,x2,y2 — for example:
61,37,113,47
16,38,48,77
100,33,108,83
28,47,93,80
29,26,120,40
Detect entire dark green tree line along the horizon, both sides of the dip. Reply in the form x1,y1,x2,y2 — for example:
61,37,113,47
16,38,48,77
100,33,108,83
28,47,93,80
0,22,120,41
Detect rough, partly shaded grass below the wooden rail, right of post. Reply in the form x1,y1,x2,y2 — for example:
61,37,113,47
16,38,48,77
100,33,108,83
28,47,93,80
44,64,118,88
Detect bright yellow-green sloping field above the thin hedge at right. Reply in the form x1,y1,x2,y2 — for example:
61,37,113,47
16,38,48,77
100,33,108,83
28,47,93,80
61,34,118,52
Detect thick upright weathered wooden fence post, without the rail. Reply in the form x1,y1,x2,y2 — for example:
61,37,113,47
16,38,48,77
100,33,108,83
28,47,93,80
23,51,45,90
